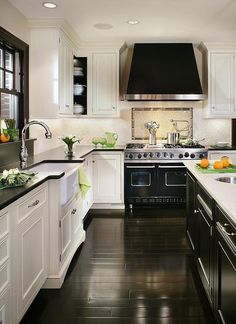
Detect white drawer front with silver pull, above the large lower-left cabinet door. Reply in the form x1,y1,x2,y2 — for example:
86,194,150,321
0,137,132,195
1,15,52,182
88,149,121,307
17,188,47,223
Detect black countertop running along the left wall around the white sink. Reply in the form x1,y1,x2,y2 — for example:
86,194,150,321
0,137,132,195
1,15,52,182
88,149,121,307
0,145,125,209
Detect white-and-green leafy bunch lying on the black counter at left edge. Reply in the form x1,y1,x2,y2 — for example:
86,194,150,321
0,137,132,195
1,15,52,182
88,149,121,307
0,168,36,189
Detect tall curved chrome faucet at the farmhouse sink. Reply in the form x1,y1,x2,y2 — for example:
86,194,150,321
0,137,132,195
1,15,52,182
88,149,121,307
20,120,52,169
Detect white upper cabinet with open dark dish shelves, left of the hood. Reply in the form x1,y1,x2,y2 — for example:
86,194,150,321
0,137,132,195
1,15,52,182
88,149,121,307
73,44,121,117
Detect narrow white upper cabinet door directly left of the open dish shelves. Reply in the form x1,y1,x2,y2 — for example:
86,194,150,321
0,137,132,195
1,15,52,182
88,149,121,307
59,36,73,115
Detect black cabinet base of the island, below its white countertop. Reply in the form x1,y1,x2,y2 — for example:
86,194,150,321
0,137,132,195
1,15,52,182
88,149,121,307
187,173,236,324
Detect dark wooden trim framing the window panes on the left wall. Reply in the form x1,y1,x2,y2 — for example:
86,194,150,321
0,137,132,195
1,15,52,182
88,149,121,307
0,26,29,134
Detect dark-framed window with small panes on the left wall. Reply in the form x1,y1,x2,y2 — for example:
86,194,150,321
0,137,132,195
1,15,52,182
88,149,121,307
0,27,29,134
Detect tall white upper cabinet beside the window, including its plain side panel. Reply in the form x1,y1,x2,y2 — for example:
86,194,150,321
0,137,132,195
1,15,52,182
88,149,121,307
29,20,76,119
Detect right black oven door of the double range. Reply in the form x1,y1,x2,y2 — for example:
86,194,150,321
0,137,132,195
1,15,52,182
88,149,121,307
158,163,186,198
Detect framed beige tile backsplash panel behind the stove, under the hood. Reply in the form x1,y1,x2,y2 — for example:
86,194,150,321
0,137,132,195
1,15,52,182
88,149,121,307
131,108,193,140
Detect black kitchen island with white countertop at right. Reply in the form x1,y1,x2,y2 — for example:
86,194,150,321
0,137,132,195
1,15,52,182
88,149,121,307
184,161,236,324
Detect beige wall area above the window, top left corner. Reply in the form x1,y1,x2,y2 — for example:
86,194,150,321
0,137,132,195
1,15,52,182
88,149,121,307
0,0,30,44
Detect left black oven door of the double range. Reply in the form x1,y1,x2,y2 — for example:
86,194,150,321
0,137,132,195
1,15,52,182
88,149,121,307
125,163,157,203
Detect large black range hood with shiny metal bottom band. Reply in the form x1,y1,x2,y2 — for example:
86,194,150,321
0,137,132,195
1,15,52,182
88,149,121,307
124,43,205,101
